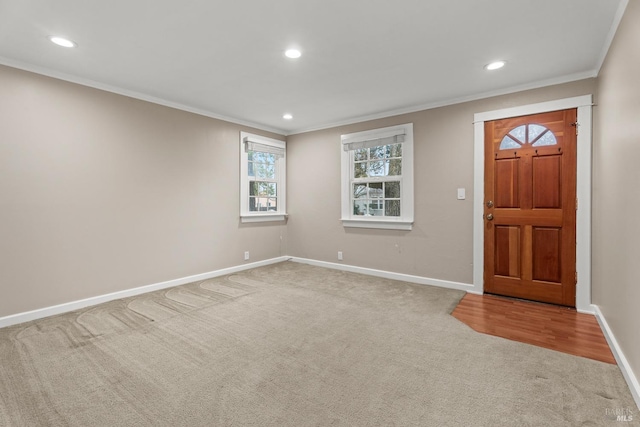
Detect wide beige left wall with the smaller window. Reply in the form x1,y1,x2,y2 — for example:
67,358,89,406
0,66,286,317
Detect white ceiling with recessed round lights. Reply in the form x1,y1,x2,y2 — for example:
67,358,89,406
0,0,627,134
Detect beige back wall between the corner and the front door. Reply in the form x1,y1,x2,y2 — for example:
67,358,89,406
287,79,596,284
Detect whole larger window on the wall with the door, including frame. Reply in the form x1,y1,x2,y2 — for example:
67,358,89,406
341,123,413,230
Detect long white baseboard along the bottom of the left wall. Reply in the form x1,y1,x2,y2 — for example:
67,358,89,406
0,256,289,328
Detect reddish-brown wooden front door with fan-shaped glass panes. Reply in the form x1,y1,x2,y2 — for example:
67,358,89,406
484,109,577,307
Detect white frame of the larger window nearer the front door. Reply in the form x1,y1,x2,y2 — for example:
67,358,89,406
340,123,414,230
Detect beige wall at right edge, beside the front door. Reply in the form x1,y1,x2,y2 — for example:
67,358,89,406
593,1,640,398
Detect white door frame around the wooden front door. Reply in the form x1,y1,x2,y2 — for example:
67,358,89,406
471,95,595,313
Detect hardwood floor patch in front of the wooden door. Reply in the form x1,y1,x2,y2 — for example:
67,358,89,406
451,294,616,365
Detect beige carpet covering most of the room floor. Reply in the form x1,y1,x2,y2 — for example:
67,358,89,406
0,262,638,427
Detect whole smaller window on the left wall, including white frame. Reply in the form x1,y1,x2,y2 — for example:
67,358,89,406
240,132,287,222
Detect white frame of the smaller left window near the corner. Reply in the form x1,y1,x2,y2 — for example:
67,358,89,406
240,132,287,222
